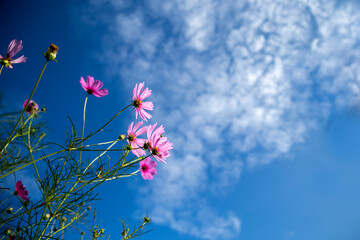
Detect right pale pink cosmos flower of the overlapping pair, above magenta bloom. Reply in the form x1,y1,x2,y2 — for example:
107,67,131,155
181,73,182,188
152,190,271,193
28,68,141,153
144,123,173,163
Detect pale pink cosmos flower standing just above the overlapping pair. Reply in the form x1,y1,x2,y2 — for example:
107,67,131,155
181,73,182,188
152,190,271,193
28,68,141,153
133,82,154,121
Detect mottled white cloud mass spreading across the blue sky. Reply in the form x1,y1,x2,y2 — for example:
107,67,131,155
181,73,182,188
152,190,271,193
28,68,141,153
80,0,360,239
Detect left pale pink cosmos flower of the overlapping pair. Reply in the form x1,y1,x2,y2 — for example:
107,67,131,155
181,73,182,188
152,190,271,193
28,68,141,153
127,121,147,157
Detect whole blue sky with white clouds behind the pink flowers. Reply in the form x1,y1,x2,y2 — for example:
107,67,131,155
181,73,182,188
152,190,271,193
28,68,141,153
0,0,360,240
